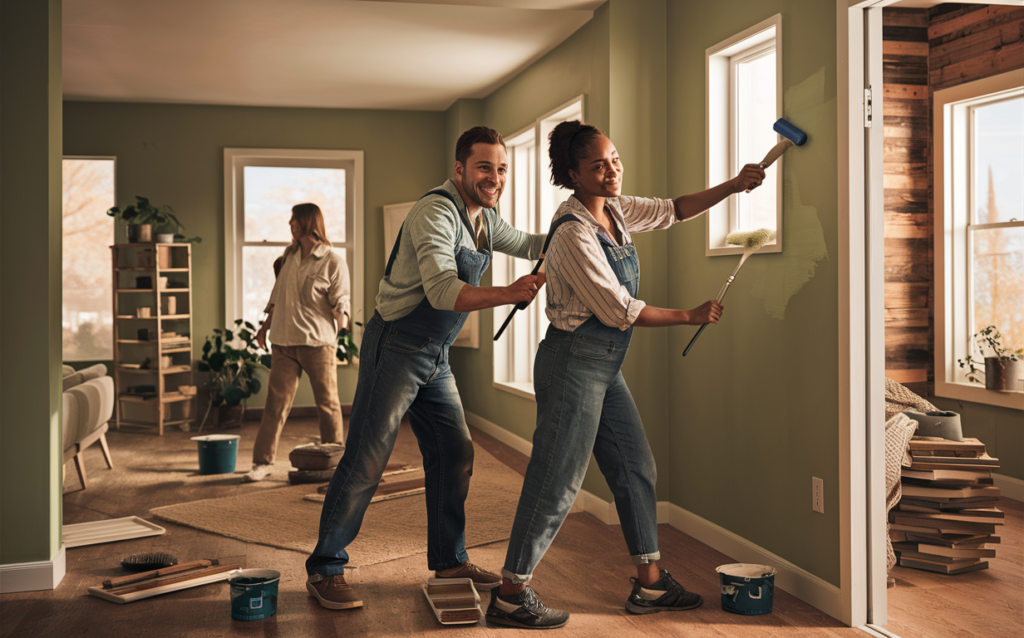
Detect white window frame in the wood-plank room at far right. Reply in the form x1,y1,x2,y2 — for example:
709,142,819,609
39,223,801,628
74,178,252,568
932,70,1024,410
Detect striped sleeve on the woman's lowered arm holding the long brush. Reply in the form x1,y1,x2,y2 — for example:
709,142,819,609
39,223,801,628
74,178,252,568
546,223,646,330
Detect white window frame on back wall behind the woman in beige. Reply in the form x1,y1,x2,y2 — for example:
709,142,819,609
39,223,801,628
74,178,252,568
224,148,365,352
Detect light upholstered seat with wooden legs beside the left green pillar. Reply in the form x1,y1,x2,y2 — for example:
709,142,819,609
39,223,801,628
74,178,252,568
62,364,114,490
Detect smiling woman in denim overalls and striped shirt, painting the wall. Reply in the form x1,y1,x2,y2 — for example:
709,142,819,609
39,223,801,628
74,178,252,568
486,121,764,629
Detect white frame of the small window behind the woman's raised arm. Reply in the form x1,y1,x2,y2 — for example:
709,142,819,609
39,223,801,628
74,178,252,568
705,13,783,257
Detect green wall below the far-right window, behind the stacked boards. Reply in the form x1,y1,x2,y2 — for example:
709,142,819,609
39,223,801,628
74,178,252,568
929,396,1024,480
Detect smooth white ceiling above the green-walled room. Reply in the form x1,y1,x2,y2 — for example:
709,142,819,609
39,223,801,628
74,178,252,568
62,0,604,111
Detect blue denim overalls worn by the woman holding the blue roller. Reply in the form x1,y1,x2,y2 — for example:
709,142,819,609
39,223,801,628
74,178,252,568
502,214,660,583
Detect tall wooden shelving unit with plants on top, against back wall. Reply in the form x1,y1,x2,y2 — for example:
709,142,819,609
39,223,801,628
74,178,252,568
111,244,196,436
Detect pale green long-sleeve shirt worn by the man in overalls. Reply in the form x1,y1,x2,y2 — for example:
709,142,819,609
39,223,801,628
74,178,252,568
377,179,546,322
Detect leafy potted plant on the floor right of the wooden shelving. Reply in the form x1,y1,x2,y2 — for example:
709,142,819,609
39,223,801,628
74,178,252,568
199,320,270,429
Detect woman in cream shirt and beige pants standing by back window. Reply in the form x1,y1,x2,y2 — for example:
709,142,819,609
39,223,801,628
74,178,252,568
244,204,349,481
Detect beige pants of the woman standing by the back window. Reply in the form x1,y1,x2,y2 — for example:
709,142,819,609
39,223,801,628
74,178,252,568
253,345,345,464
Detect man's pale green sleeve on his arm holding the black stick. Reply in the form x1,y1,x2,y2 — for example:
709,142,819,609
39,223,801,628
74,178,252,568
411,202,466,310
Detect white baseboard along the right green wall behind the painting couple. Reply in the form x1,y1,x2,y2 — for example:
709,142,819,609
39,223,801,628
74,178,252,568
466,412,839,619
